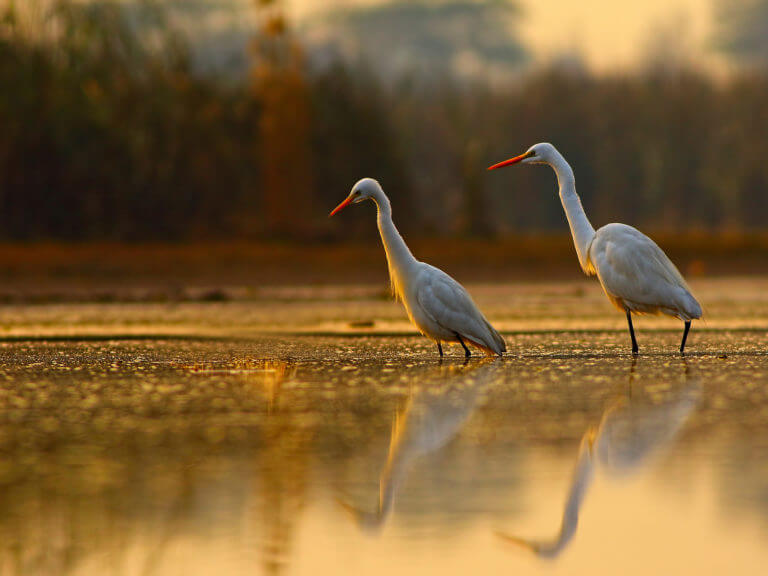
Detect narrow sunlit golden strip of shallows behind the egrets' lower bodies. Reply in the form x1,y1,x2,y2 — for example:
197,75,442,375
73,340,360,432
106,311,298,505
0,276,768,338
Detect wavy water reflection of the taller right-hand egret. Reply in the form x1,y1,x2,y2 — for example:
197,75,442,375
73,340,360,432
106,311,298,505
498,362,700,559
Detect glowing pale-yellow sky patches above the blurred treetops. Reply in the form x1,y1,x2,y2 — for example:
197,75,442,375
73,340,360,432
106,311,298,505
16,0,729,73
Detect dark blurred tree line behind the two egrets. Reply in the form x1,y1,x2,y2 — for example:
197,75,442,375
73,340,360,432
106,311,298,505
0,0,768,241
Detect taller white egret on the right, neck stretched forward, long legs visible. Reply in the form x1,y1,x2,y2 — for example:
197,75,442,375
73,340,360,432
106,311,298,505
488,142,701,354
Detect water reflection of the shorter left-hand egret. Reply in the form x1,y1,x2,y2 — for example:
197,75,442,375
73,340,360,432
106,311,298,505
339,360,502,533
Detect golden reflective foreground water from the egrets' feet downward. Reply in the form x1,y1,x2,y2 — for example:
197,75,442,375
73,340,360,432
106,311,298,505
0,326,768,576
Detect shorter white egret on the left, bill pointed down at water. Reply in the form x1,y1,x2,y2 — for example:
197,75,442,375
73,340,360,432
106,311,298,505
329,178,507,358
